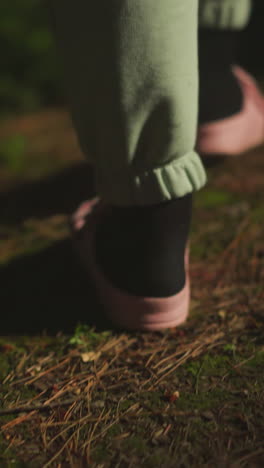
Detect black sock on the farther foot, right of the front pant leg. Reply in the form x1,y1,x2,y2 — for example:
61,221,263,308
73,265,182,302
199,29,243,124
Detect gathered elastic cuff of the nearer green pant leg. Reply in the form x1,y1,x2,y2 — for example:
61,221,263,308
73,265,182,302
95,151,207,206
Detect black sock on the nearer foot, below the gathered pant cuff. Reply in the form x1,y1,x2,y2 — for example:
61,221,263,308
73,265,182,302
96,194,192,297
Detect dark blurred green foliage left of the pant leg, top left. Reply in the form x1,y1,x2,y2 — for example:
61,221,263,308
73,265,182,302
0,0,62,114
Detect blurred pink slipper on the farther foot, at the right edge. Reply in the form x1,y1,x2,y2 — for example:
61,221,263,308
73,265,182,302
196,66,264,156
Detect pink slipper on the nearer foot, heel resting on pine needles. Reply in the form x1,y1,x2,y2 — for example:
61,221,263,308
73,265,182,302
70,198,190,331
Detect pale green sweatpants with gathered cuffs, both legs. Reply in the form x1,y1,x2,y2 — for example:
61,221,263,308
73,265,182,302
48,0,251,206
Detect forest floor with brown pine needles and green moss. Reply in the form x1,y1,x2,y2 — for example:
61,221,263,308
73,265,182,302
0,104,264,468
